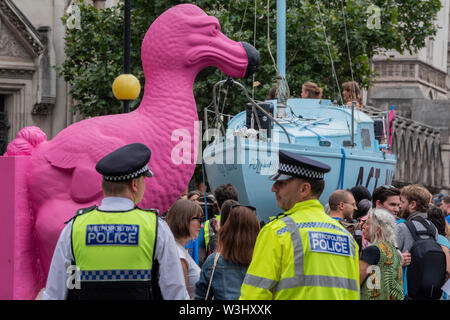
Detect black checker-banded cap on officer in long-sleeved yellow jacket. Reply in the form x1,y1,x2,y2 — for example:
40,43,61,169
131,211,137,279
269,150,331,181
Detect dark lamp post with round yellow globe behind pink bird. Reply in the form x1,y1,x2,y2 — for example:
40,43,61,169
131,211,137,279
112,0,141,113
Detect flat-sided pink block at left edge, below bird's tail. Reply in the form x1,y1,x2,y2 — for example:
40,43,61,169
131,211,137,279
0,156,45,300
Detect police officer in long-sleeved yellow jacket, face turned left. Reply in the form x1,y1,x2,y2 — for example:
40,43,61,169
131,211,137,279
240,150,359,300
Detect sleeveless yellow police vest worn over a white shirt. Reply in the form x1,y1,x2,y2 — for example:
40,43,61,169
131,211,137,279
72,208,157,281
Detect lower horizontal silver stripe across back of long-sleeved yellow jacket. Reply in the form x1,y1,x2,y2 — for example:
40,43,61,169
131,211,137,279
277,275,359,291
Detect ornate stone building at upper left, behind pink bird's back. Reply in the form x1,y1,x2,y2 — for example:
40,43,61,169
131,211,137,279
0,0,111,154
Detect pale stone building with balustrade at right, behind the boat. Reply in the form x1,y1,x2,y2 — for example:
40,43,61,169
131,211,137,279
367,0,450,193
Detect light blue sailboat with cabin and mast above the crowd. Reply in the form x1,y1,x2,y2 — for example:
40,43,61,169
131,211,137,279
203,0,397,222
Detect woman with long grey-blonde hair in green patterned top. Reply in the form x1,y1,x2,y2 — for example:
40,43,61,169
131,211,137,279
359,209,403,300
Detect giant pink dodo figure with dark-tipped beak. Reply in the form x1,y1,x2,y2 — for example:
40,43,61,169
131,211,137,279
5,4,259,293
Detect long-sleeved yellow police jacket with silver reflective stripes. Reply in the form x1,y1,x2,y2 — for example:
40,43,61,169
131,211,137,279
240,200,359,300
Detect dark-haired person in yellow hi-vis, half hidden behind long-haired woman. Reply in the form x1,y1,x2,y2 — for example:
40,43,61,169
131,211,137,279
199,183,239,263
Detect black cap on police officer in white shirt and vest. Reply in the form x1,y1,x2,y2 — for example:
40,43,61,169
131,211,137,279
95,143,153,182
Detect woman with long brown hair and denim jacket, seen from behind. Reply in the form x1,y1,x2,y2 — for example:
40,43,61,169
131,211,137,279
195,205,259,300
